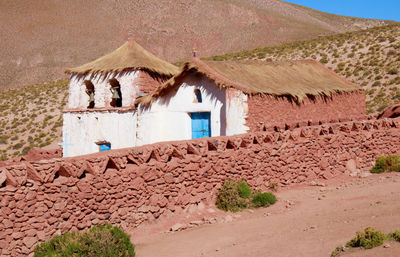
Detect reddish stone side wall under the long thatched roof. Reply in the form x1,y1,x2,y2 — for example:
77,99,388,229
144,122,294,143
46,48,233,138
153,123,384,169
246,91,366,131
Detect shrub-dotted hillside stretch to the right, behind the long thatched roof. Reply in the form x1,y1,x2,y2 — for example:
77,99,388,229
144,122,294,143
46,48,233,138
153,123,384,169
206,24,400,113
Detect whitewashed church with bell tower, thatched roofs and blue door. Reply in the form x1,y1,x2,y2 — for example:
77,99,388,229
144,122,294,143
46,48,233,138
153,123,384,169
62,41,365,157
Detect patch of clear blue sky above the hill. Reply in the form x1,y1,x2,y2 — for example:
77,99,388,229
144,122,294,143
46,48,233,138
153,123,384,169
283,0,400,21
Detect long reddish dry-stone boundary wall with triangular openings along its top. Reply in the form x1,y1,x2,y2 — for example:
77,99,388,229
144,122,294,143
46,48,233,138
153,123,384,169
0,118,400,256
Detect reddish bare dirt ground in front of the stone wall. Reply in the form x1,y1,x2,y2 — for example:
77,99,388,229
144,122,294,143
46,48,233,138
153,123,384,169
130,173,400,257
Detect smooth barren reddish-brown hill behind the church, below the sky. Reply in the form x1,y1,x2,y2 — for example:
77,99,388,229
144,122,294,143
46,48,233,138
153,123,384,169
0,0,387,88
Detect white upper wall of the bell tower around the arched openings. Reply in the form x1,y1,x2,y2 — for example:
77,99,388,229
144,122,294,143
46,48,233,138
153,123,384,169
68,71,141,109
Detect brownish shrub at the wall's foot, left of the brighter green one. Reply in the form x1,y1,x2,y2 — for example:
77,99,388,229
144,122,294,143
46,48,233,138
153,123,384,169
217,180,248,212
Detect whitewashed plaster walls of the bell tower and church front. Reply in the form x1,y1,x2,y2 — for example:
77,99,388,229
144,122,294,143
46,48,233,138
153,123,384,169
63,71,248,157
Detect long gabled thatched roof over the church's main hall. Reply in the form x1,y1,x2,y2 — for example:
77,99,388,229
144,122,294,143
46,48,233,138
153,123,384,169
137,59,362,106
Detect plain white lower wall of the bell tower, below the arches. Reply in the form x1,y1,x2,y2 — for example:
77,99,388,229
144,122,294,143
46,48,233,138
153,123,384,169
63,111,136,157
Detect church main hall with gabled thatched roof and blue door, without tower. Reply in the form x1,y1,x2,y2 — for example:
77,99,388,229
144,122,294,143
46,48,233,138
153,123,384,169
136,59,366,143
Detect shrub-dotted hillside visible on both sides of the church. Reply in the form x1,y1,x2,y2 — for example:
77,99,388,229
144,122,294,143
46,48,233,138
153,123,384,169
0,25,400,160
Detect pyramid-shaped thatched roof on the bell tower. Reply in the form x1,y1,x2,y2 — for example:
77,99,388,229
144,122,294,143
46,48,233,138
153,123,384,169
66,40,179,77
